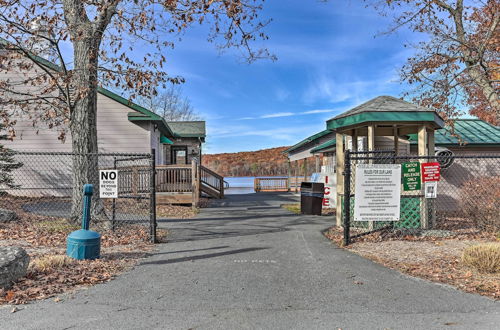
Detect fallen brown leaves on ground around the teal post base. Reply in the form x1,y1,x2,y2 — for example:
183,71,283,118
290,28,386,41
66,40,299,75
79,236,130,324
0,196,165,306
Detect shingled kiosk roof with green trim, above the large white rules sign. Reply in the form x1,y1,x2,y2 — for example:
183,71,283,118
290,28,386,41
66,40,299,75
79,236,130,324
326,96,444,130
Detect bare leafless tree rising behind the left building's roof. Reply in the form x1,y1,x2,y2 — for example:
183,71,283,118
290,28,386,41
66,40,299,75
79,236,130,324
139,84,201,121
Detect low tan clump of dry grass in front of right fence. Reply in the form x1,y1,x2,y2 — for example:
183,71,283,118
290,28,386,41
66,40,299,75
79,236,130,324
462,243,500,273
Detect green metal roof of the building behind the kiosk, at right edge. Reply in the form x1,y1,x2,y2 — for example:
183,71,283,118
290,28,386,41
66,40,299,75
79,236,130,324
409,119,500,147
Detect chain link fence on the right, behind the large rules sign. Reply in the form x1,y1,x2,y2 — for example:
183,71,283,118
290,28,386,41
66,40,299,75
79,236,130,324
341,151,500,244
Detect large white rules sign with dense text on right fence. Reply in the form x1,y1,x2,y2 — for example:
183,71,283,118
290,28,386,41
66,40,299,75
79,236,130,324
354,164,401,221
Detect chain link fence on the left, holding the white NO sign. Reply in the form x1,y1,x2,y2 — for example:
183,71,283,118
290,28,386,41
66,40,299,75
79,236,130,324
0,151,156,241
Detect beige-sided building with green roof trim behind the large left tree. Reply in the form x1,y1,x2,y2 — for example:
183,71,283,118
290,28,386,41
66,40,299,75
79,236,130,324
0,40,206,165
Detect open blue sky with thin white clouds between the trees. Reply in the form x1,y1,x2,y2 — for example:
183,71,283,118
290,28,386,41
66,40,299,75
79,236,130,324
151,0,416,153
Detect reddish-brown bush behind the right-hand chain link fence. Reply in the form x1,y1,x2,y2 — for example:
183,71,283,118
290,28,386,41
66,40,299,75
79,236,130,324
460,177,500,232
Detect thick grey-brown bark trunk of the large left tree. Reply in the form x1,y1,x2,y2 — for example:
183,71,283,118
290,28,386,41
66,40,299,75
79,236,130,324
70,38,107,224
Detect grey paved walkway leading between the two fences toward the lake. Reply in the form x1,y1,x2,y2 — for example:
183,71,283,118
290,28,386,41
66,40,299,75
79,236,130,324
0,194,500,329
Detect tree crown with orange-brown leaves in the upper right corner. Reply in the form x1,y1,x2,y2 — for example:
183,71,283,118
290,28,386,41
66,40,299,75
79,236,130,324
377,0,500,125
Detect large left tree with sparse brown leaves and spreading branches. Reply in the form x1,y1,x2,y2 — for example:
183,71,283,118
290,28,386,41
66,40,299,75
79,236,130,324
0,0,269,224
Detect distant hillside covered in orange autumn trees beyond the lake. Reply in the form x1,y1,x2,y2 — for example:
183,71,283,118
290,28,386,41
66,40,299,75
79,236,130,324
202,147,288,176
